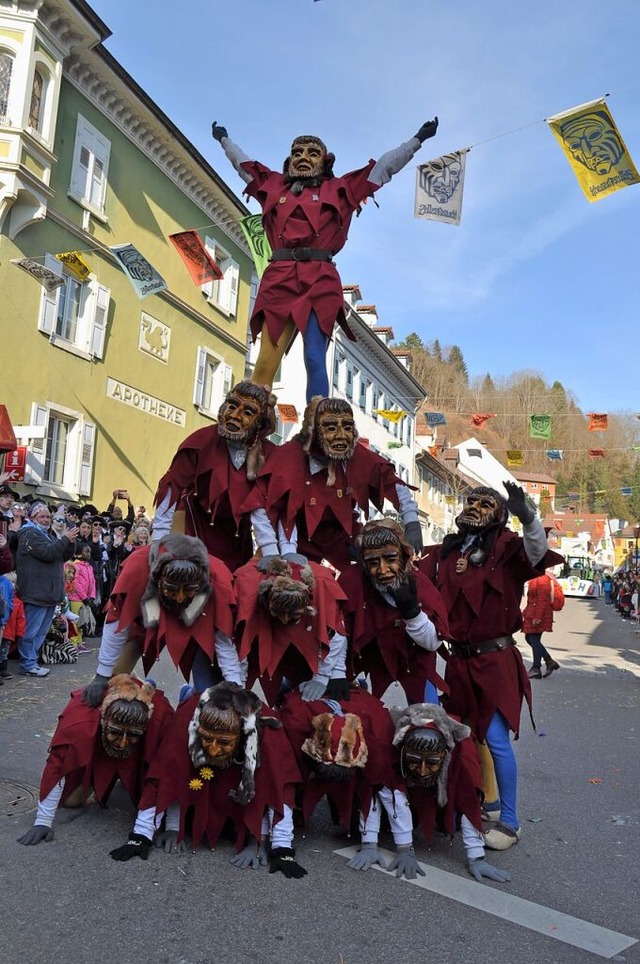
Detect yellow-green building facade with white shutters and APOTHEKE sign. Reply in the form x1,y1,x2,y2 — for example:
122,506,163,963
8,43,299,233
0,0,256,509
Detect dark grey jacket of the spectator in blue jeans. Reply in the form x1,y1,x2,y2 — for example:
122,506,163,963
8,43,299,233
16,522,74,606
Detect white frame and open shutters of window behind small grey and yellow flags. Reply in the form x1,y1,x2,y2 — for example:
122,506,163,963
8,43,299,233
38,254,111,361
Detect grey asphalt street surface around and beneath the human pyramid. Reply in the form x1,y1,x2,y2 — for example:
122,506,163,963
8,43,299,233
0,599,640,964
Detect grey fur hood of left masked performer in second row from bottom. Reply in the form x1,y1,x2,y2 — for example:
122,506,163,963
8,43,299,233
140,532,213,629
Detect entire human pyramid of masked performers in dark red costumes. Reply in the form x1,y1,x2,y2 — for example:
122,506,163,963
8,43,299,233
19,119,556,882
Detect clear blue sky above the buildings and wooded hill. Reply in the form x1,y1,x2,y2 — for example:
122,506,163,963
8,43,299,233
87,0,640,412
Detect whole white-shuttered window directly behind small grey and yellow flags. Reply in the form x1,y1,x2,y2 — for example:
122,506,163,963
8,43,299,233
38,254,111,360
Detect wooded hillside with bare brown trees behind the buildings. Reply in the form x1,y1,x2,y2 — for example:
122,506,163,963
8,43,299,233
394,333,640,520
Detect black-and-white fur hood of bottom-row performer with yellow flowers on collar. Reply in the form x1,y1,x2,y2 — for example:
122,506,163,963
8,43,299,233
189,683,268,806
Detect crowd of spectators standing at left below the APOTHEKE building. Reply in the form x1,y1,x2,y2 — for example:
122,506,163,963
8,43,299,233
0,476,152,686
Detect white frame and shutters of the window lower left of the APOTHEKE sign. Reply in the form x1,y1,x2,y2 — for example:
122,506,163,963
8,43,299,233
25,401,96,498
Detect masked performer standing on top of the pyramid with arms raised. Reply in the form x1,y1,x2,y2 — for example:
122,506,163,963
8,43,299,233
211,117,438,401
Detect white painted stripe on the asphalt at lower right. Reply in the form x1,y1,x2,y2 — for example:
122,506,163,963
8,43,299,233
333,847,638,959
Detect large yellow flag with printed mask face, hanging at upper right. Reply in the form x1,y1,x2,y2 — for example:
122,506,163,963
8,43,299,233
547,99,640,201
